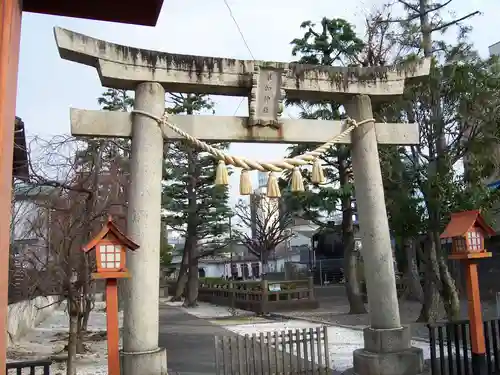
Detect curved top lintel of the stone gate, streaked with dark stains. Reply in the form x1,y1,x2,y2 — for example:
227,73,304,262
54,27,430,100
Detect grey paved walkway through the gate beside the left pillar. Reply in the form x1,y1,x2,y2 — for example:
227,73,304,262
159,305,237,375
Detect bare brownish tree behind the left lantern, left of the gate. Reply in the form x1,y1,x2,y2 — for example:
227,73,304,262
20,137,126,375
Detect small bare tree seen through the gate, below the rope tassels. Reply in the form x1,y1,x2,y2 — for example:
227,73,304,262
235,194,293,277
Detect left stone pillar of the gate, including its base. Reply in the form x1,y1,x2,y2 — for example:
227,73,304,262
122,82,167,375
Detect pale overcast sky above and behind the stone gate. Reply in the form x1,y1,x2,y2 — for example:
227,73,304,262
16,0,500,207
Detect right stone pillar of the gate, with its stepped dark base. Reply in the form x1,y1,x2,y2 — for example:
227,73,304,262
346,95,424,375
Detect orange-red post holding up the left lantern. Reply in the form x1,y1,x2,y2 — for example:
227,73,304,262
106,279,120,375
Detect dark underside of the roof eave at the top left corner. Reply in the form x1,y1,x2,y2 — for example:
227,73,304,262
23,0,163,26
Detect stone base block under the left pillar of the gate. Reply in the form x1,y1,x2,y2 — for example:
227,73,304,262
120,348,167,375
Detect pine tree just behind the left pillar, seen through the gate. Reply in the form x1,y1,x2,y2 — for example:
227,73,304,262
163,94,232,307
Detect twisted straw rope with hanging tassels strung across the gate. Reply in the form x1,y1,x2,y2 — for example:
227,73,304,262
132,110,375,198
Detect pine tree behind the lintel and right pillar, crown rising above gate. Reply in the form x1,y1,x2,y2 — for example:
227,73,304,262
287,17,366,314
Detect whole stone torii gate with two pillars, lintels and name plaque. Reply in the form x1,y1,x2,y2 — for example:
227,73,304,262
55,28,430,375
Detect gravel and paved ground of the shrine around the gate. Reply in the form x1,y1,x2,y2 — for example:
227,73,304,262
8,286,496,375
